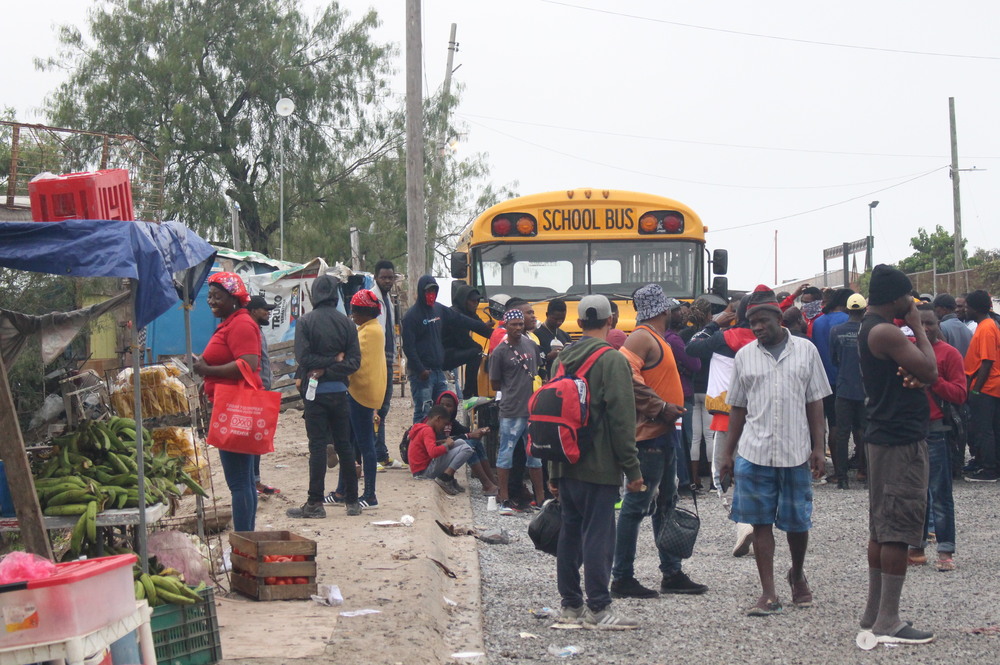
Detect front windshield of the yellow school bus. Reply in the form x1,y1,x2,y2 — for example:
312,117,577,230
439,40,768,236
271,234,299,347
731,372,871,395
473,240,702,300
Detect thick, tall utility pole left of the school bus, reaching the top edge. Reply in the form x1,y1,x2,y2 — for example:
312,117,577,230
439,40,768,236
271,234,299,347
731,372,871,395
406,0,427,304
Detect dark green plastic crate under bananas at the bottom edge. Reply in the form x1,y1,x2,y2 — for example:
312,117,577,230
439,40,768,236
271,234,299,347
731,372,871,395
150,588,222,665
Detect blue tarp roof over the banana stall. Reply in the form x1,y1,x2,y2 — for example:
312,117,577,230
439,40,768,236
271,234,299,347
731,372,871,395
0,219,215,328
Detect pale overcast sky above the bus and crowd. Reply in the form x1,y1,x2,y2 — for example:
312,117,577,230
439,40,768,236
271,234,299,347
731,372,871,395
9,0,1000,288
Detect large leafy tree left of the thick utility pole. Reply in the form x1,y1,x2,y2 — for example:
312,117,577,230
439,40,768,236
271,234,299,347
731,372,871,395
42,0,401,259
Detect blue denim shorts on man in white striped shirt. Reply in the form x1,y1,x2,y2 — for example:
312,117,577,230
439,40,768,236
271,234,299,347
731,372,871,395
729,457,812,533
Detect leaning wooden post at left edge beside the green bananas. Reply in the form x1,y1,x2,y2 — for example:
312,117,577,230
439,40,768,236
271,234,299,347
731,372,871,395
0,358,52,560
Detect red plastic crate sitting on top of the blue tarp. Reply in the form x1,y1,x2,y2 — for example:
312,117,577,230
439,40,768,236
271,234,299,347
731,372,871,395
28,169,135,222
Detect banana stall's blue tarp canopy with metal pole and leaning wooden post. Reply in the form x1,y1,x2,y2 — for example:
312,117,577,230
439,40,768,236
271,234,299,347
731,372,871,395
0,220,215,570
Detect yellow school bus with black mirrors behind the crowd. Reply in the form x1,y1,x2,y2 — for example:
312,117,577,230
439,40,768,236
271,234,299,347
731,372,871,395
451,188,728,338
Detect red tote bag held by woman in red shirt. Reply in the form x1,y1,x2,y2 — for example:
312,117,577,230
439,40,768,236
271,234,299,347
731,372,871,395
208,359,281,455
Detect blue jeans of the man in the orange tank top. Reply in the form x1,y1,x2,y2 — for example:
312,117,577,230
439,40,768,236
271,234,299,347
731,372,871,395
611,431,681,580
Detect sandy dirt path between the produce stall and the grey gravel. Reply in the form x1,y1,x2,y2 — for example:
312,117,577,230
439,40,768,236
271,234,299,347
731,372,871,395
184,398,484,665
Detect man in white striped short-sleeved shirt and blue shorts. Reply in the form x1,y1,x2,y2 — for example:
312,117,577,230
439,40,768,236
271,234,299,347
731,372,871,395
719,285,831,616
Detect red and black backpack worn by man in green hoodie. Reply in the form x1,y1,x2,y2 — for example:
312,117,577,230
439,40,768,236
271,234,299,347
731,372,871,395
528,345,612,464
